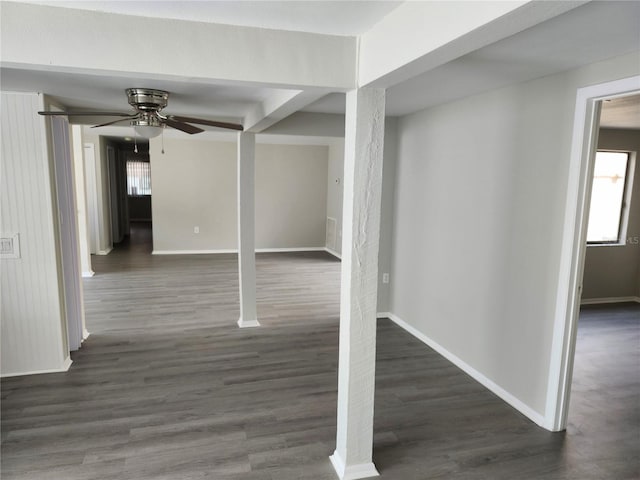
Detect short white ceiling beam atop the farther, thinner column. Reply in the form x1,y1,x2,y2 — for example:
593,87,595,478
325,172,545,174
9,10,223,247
243,90,328,133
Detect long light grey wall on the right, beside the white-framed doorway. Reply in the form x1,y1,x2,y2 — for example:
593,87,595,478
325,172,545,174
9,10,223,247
389,52,640,422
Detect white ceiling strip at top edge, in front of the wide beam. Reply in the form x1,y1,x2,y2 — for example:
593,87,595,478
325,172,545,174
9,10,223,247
8,0,402,36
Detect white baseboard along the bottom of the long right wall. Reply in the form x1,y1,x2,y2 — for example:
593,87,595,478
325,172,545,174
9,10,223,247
378,313,544,426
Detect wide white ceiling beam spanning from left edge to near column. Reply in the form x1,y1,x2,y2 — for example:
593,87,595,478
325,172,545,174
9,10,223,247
0,2,357,91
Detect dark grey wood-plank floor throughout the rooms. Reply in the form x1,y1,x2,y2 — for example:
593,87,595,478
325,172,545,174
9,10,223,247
1,226,640,480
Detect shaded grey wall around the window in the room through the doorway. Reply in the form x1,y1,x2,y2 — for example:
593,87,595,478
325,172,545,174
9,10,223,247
582,129,640,300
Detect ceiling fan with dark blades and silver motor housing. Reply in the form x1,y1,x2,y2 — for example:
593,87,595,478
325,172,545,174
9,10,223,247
38,88,243,138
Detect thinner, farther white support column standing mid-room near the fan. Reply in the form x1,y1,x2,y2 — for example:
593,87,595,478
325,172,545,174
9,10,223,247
238,132,260,328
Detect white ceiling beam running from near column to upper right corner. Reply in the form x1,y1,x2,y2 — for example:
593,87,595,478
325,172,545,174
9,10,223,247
358,0,588,88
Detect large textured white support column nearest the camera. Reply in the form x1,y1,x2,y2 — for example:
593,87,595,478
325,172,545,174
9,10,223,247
331,88,385,480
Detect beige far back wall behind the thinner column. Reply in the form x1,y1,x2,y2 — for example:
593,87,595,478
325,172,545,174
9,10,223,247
150,138,328,253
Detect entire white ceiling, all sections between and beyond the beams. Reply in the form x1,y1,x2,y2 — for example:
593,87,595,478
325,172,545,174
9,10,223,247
1,1,640,133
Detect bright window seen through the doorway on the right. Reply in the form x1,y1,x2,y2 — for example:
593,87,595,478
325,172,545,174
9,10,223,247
587,151,630,244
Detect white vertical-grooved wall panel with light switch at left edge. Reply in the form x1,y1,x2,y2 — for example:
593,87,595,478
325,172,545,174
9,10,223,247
0,92,68,376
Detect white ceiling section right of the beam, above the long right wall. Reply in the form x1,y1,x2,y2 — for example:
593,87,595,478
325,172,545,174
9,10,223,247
304,1,640,116
